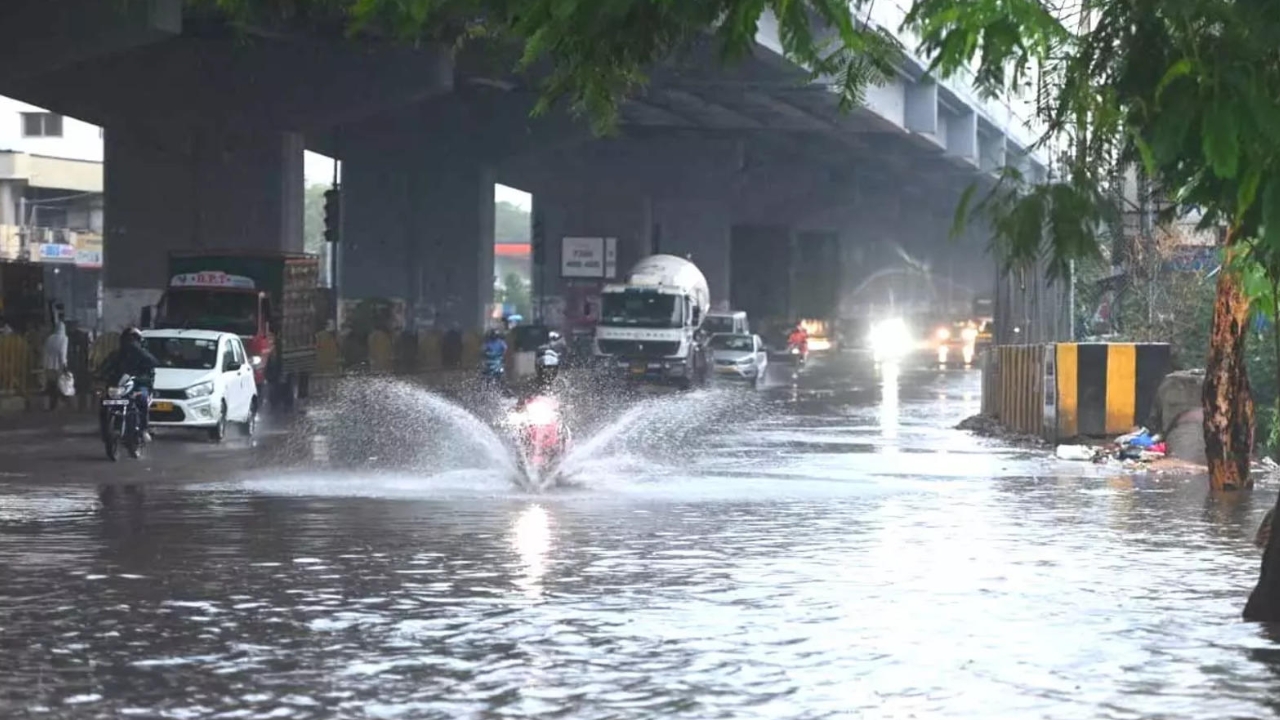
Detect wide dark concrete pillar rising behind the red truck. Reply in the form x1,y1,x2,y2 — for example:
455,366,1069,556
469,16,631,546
102,122,303,329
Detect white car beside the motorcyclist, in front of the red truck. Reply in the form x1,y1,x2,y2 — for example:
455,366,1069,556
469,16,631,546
142,329,259,442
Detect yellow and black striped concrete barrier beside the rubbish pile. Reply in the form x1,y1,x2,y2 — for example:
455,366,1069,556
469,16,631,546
982,342,1170,442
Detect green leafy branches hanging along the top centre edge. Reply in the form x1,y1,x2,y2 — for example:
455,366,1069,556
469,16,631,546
204,0,901,131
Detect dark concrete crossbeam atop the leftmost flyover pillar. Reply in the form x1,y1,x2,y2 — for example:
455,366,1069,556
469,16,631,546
0,36,453,131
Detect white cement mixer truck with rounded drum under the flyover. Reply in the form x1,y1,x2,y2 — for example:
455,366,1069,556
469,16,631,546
594,255,710,388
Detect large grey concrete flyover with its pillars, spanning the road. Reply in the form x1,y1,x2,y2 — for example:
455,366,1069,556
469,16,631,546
0,0,1044,327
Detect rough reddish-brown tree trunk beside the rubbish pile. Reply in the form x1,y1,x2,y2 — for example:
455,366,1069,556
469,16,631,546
1203,231,1253,491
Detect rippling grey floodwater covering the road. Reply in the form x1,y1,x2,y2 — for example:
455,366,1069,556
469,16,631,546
0,359,1280,720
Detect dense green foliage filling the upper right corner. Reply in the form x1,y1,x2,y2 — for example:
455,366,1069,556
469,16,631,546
908,0,1280,278
